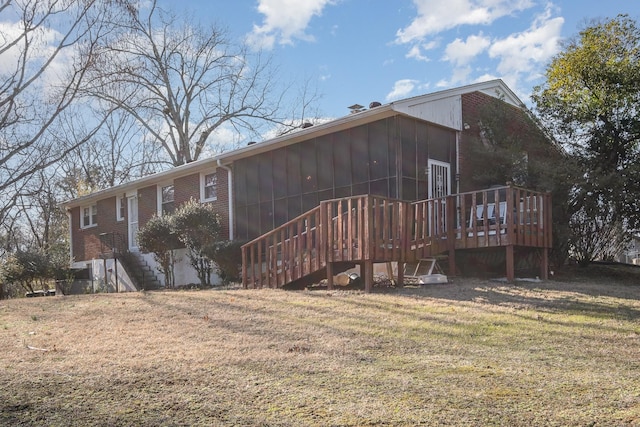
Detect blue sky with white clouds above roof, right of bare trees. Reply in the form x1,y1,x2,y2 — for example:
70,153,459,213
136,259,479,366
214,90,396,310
159,0,640,117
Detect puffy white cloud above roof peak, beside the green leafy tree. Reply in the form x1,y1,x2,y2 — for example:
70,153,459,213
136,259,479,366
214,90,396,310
489,9,564,79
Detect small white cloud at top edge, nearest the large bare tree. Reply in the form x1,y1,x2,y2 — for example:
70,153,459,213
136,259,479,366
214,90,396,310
247,0,334,49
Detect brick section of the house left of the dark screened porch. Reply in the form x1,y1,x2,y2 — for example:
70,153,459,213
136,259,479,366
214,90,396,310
63,158,233,290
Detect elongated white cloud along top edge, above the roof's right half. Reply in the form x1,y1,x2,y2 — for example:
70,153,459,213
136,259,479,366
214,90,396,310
396,0,535,44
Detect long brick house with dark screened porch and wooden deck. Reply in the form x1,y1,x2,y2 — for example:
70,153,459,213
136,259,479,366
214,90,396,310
64,80,552,294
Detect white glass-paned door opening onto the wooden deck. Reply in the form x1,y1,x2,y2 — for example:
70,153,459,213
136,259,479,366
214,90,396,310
427,159,451,236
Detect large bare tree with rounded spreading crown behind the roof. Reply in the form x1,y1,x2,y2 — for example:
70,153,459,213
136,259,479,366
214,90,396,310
85,1,316,166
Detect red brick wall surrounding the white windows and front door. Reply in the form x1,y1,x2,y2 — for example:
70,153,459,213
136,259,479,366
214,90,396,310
70,168,229,262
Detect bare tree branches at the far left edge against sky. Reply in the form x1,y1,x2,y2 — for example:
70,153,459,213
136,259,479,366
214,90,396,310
0,0,133,224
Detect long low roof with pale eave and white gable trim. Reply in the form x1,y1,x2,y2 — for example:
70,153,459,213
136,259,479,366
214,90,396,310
61,79,524,209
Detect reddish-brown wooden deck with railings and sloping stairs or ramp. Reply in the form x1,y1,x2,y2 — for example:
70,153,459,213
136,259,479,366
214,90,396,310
242,186,551,291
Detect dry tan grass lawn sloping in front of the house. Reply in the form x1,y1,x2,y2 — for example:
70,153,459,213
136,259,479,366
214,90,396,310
0,270,640,426
